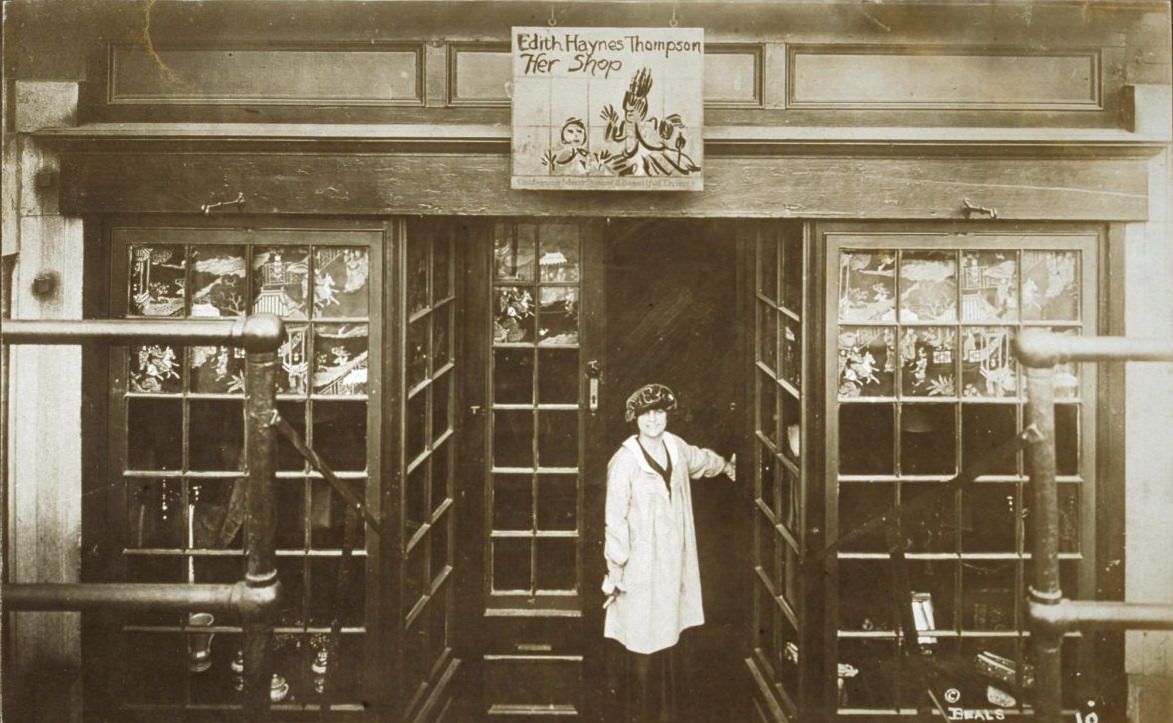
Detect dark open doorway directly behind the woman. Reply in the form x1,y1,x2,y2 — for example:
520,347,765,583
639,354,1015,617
595,219,752,722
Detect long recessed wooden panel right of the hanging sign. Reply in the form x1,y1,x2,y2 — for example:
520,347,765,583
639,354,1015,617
788,46,1100,110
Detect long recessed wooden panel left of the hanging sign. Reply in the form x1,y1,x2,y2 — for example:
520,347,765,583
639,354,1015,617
109,46,422,106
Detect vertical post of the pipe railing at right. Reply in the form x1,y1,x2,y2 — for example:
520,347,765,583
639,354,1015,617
1026,366,1063,723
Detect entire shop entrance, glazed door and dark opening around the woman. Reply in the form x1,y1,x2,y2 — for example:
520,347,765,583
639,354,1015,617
457,219,752,721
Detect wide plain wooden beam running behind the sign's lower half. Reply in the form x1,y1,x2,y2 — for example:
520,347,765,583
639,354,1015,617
60,150,1147,221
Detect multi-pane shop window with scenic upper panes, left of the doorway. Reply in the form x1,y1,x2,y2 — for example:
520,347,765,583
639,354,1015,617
111,229,381,716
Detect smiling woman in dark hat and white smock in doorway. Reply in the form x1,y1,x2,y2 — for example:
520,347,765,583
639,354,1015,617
603,384,735,722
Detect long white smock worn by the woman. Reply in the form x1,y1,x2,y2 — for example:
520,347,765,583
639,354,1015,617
603,432,725,654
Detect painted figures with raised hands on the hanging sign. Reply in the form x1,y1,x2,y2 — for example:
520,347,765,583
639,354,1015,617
541,68,700,177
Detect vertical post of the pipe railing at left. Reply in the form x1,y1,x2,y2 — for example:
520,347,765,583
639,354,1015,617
244,317,283,723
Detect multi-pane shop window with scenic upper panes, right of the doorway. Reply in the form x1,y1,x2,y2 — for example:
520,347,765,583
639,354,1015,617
828,234,1096,715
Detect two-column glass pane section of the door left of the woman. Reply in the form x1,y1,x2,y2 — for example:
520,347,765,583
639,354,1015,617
487,223,582,597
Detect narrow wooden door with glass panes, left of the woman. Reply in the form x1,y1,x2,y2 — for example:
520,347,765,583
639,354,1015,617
462,221,601,716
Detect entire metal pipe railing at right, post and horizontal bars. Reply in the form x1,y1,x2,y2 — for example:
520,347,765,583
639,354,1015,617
1015,329,1173,723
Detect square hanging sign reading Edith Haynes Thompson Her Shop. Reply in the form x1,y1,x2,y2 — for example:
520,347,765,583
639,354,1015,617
513,27,705,190
